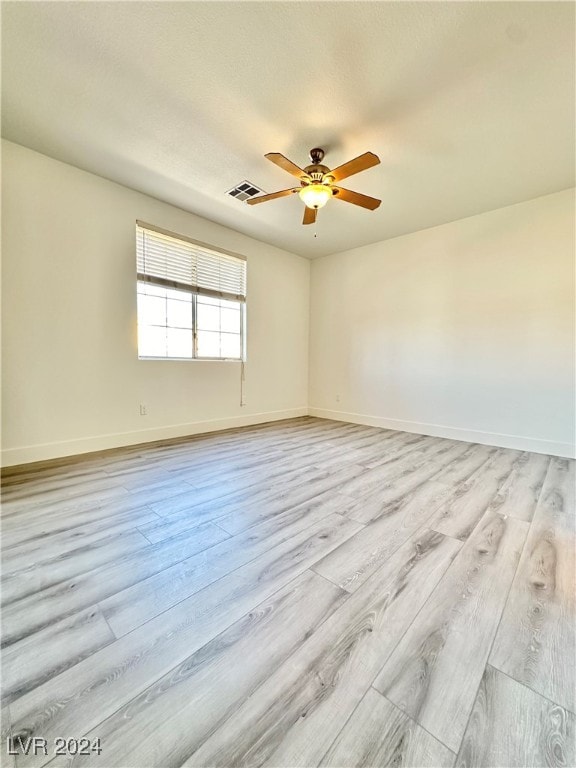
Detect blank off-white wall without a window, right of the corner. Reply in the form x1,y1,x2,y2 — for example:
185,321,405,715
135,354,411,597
309,190,575,455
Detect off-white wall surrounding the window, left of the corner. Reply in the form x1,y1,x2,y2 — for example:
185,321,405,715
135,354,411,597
2,142,310,464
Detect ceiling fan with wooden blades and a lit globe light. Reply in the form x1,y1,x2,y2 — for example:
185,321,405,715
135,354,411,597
246,147,381,224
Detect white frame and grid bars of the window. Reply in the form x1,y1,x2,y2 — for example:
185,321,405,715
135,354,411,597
136,221,247,363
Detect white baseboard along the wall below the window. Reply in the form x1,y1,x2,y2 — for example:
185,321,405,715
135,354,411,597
2,406,308,467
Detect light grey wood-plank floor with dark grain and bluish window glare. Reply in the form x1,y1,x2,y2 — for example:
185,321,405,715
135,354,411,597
0,418,576,768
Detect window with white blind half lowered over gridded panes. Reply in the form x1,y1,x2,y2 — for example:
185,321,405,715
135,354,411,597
136,222,246,360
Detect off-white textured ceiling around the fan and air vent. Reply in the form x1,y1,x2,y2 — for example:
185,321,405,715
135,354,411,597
2,0,575,257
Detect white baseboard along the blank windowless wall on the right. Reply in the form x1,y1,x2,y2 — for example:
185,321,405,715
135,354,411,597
308,408,576,459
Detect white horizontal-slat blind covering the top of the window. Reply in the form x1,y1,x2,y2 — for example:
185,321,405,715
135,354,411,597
136,221,246,302
